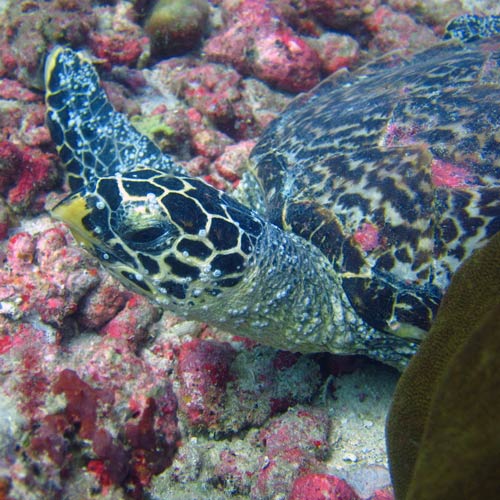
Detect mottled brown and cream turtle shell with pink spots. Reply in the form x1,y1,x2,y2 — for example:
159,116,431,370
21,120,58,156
252,37,500,332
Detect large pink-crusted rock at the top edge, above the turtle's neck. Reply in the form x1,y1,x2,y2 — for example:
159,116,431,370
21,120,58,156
204,0,321,92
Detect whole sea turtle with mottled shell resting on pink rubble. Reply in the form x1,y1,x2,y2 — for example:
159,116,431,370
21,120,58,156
45,16,500,368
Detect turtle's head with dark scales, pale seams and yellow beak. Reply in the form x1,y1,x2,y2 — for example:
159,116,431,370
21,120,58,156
53,169,263,313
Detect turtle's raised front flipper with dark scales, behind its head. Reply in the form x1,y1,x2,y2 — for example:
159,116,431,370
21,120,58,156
45,47,184,191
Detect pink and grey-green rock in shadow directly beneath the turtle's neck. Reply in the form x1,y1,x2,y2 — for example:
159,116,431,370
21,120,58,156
177,340,321,434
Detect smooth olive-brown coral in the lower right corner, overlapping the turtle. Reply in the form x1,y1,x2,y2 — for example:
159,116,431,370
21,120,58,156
387,233,500,500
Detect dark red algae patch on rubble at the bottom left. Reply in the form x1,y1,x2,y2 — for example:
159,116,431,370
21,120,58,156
29,369,180,498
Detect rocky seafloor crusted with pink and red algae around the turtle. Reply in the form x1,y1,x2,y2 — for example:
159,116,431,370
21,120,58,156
0,0,500,500
